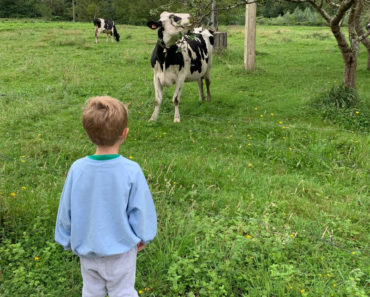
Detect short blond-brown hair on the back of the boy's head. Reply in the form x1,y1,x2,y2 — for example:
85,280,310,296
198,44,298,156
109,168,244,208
82,96,128,146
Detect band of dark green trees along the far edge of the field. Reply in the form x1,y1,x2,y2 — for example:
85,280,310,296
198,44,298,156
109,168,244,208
0,0,318,25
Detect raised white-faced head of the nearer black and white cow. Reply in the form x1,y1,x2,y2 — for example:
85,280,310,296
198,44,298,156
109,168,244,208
147,11,194,47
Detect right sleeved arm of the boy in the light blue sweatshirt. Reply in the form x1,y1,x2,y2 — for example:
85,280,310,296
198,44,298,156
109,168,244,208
127,169,157,244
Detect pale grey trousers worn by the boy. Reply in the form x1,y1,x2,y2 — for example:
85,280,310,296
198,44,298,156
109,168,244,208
80,247,138,297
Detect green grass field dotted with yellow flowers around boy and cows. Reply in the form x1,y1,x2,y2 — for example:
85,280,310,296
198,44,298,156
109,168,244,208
0,20,370,297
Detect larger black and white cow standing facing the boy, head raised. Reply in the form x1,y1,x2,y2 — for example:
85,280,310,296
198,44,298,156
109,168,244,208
147,12,214,122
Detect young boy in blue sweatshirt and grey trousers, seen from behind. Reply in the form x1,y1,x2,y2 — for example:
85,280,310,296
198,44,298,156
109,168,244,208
55,96,157,297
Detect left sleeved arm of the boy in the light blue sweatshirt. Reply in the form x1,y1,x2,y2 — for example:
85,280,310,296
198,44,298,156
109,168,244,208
55,170,72,250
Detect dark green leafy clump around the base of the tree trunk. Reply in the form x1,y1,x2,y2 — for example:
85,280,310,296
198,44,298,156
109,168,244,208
313,85,370,130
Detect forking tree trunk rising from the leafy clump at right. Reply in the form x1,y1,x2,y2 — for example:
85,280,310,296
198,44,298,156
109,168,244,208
285,0,364,88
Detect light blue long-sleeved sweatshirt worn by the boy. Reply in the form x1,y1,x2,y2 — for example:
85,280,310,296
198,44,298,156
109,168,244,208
55,155,157,257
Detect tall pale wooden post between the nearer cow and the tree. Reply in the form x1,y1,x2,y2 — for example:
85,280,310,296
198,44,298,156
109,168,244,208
244,3,257,70
